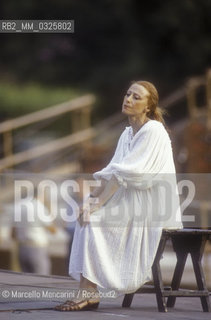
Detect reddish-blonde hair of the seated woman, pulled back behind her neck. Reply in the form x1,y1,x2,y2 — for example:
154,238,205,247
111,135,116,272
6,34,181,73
133,81,166,124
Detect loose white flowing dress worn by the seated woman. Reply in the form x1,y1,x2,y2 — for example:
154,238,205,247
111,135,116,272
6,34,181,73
69,120,182,294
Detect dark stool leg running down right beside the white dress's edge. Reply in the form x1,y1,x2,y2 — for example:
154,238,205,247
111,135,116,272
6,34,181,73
152,237,167,312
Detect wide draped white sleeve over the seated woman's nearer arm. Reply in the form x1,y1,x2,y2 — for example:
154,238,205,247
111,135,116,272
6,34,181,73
94,120,175,189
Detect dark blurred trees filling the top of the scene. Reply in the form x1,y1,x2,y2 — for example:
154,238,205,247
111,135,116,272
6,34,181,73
0,0,211,119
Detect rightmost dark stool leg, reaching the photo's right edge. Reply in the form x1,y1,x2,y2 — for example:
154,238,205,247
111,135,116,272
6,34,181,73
191,237,211,312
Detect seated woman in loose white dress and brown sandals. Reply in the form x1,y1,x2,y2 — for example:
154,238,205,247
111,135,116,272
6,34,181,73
55,81,182,311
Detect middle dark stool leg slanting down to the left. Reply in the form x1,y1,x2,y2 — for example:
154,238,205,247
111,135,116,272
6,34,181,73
167,252,188,308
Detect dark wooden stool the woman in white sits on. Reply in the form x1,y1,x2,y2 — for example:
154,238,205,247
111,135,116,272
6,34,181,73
122,229,211,312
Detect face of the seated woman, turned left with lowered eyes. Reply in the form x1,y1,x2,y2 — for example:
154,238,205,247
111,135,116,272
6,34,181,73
122,83,149,116
